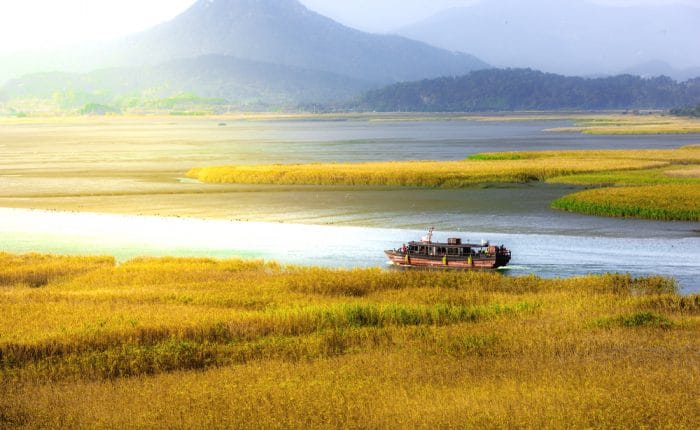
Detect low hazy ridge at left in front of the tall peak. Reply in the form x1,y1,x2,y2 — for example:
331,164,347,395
0,55,372,110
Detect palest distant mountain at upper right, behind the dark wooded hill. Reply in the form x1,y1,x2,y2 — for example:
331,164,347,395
396,0,700,79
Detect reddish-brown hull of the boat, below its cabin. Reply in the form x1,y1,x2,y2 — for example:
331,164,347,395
384,250,510,270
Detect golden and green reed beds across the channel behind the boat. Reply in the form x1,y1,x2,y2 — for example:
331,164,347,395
187,145,700,221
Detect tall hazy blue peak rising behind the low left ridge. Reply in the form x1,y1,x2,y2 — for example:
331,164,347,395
0,0,487,84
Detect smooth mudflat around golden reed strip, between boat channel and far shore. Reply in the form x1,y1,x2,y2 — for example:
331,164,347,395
0,114,700,276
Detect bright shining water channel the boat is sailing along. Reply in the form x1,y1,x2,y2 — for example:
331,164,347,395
0,209,700,293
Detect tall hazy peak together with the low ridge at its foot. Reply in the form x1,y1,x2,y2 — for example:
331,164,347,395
4,0,488,107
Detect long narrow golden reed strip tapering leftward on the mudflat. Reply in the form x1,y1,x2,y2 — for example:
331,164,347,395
187,146,700,188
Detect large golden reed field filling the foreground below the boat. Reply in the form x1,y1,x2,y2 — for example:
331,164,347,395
0,254,700,428
